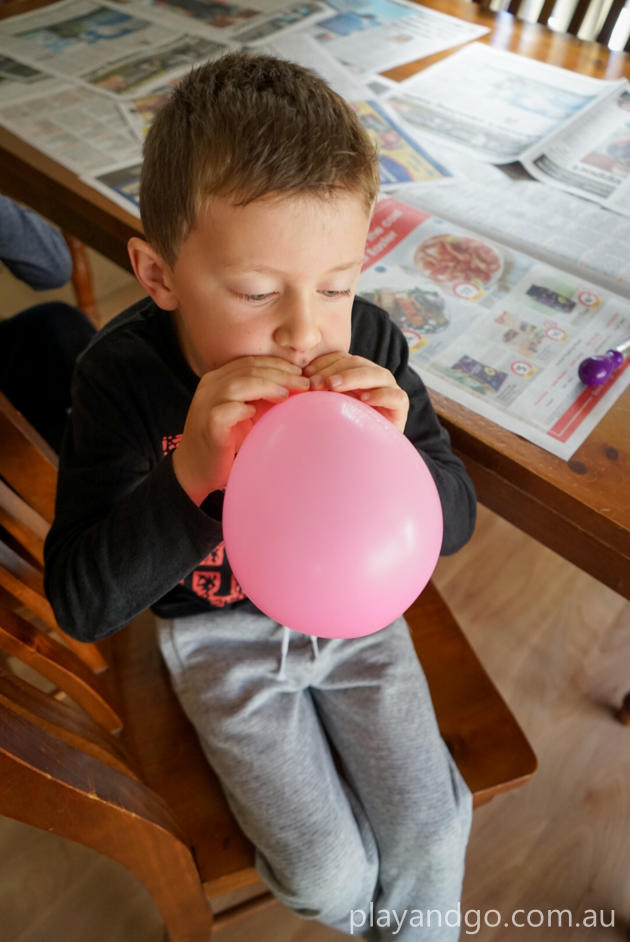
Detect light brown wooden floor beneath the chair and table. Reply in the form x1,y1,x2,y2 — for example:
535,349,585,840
0,247,630,942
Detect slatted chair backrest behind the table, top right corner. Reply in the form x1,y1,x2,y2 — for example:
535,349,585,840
473,0,630,52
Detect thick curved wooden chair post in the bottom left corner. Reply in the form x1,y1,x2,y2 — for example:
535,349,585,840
0,709,213,942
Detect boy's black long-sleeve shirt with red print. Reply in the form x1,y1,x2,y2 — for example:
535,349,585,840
45,298,476,641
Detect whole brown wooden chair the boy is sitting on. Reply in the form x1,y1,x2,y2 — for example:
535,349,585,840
0,390,536,942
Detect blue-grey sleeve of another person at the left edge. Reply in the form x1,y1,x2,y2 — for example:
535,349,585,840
0,196,72,291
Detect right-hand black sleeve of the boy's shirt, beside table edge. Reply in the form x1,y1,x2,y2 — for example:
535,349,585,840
351,299,477,555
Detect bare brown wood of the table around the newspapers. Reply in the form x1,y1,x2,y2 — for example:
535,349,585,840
0,0,630,599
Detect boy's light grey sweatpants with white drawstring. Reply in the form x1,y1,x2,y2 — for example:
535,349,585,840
158,611,472,942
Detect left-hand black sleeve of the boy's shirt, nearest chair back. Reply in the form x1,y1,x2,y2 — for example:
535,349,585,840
45,340,221,641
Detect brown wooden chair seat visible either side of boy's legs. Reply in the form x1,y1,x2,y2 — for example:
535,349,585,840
103,584,536,896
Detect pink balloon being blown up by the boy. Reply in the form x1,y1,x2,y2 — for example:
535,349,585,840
223,392,442,638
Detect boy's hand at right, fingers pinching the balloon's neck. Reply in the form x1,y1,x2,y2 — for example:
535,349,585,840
304,351,409,432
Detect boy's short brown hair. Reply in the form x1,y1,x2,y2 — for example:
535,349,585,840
140,52,379,265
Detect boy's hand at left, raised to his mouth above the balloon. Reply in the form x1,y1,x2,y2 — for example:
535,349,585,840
173,356,308,505
